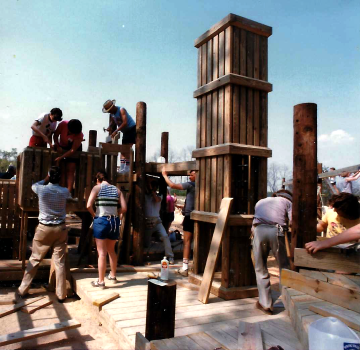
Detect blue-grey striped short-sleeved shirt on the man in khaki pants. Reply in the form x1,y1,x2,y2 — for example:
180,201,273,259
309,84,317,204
31,180,71,225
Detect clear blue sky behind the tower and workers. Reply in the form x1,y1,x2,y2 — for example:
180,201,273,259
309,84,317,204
0,0,360,172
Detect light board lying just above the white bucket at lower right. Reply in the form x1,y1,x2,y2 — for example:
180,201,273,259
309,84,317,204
309,302,360,331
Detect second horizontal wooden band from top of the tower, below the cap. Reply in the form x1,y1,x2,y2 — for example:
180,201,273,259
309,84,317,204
193,73,272,98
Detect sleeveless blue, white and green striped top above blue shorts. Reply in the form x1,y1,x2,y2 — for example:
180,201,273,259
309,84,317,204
95,184,120,216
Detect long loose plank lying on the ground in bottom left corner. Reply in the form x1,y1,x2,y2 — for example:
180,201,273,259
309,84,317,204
0,320,81,346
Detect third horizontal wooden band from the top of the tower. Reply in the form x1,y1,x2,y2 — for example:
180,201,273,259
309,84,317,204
192,143,272,158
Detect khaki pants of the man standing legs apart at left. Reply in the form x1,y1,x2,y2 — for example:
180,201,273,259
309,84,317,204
19,223,68,299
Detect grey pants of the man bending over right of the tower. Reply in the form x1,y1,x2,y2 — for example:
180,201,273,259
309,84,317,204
252,225,289,309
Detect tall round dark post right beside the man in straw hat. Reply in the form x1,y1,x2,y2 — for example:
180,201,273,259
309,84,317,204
133,102,146,265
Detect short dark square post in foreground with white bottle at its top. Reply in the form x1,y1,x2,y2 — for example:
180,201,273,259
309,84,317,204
145,279,176,341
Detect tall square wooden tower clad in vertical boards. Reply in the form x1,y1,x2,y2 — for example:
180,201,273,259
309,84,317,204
192,14,272,299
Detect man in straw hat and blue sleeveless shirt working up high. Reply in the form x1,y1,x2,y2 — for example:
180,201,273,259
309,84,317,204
102,100,136,173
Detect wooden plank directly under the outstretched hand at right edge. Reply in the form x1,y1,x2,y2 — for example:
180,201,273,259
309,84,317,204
294,248,360,273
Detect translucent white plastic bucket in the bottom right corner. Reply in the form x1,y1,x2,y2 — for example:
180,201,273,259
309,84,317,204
309,317,360,350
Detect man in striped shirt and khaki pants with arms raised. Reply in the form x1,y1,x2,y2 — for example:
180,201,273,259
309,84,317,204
17,167,71,302
